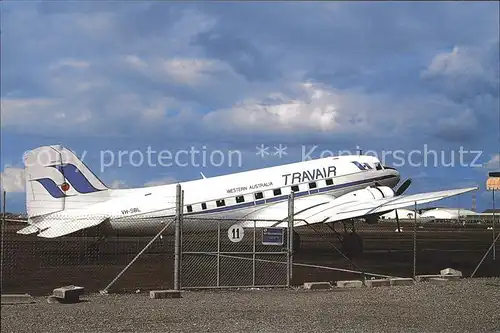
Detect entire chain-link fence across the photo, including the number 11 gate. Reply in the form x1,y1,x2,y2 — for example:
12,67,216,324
2,213,500,295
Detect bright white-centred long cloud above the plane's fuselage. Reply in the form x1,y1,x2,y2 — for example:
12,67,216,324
203,81,478,144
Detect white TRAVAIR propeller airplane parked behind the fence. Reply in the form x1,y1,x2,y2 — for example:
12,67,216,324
18,145,477,253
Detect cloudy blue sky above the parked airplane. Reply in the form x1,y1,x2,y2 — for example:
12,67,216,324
1,1,500,212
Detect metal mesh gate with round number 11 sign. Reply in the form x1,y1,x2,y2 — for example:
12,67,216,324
181,218,292,289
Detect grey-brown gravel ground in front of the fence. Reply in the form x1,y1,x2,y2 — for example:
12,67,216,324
1,278,500,333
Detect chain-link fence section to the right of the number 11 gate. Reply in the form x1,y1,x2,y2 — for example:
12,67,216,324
292,219,500,284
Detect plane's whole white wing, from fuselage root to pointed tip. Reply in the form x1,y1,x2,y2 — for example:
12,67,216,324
234,187,477,228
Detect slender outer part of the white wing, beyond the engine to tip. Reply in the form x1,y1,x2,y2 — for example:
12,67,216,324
309,187,477,223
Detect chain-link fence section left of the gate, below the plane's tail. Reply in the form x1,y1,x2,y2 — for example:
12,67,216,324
2,217,174,295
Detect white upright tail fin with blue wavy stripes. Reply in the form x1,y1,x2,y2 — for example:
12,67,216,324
24,145,109,217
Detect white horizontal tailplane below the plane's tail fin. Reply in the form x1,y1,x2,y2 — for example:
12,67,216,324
17,216,107,238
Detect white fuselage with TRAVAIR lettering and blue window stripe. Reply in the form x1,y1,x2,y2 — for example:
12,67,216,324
96,156,399,235
